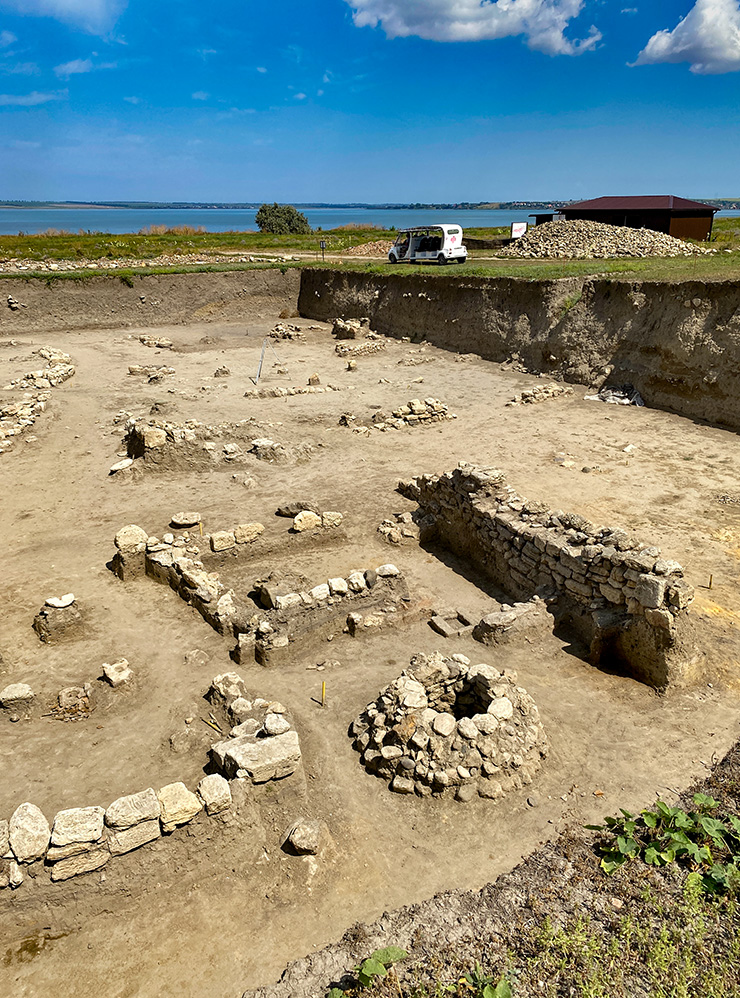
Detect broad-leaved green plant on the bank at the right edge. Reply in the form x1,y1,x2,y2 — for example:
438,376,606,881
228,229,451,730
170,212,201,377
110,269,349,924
586,794,740,893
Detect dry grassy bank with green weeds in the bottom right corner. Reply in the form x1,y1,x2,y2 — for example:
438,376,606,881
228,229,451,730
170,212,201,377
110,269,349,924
326,745,740,998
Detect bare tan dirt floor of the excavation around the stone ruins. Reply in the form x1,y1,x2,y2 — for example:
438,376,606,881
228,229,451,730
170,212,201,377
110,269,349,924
0,312,740,998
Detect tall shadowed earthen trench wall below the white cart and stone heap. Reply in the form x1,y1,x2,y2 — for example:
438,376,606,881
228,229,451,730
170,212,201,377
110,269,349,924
298,269,740,430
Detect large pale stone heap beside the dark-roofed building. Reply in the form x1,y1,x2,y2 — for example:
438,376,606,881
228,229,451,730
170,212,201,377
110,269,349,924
501,219,714,259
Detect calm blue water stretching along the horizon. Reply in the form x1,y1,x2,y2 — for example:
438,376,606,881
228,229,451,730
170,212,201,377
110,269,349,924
0,207,740,235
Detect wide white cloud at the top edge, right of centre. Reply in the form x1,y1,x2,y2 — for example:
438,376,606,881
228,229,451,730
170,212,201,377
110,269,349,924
346,0,601,55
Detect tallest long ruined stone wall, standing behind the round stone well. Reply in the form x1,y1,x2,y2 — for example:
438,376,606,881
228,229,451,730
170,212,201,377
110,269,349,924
399,462,695,688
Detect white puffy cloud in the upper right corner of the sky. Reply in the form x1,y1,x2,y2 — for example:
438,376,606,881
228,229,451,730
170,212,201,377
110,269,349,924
632,0,740,74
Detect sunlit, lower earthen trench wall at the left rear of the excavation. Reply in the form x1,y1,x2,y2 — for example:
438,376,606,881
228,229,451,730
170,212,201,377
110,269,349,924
0,269,299,335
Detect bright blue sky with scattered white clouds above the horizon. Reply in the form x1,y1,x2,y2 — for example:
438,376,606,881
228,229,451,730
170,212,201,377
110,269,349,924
0,0,740,202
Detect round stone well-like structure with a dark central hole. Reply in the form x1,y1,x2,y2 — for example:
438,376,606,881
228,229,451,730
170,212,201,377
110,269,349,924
350,652,548,801
